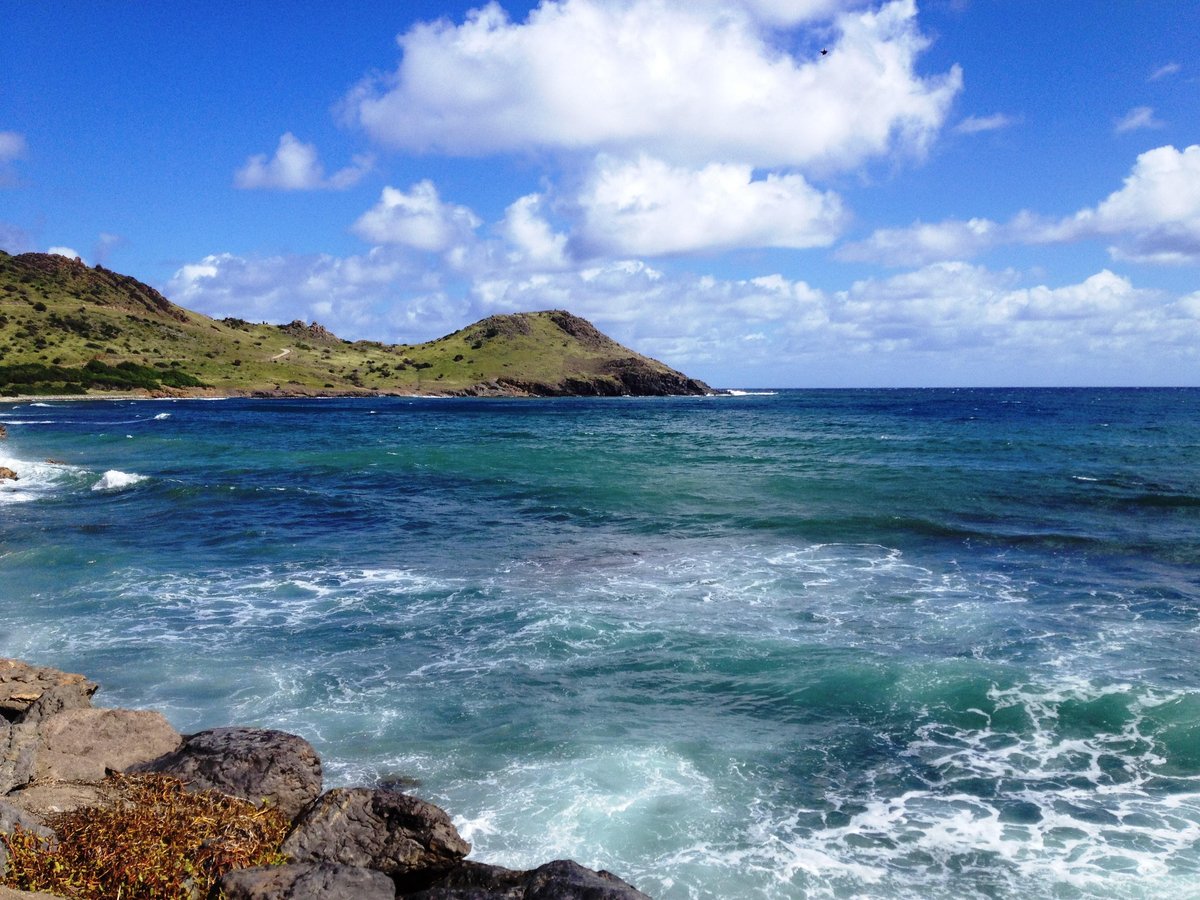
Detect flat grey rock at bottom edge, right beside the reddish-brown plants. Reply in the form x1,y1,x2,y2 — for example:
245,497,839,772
217,863,396,900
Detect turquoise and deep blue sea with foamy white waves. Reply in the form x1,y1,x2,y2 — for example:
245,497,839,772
0,390,1200,899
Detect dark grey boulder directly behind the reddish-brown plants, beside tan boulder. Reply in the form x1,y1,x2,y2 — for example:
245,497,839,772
131,728,320,818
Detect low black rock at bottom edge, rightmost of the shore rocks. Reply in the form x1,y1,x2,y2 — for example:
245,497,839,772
404,859,650,900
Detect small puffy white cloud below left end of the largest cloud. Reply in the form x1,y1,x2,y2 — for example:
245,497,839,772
354,180,482,253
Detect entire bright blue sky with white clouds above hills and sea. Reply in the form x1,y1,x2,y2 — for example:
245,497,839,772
0,0,1200,386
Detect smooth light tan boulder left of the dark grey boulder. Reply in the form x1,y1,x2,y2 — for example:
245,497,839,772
34,709,182,781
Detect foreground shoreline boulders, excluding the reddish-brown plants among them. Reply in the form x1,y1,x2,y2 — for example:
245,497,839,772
0,659,648,900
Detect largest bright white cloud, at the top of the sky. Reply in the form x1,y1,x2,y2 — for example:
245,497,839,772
344,0,961,170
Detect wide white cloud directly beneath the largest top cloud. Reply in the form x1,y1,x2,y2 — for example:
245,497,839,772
578,156,846,256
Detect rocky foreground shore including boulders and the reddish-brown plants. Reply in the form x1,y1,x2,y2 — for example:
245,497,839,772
0,659,649,900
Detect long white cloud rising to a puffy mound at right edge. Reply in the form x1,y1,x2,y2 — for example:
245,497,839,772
838,144,1200,266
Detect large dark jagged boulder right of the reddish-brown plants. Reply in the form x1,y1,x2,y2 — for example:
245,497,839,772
282,787,470,889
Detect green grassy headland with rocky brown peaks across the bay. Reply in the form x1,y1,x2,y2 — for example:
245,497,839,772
0,251,710,396
